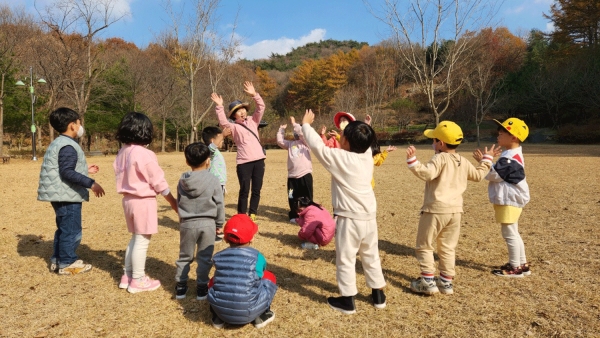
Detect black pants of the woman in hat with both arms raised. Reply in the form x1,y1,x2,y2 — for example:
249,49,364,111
236,159,265,215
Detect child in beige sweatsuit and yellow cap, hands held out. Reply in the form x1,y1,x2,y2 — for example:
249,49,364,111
406,121,497,295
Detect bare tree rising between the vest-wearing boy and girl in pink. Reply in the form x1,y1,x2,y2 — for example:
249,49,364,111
36,0,128,133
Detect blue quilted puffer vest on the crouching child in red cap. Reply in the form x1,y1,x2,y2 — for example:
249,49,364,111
208,247,277,325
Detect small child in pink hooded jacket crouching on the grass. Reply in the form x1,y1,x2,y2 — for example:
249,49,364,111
296,196,335,246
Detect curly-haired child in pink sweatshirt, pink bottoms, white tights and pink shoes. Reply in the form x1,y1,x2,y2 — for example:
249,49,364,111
113,112,177,293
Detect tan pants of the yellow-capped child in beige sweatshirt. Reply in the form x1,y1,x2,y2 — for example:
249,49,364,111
415,212,462,276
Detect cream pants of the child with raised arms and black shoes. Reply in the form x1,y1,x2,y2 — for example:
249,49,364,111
335,216,385,296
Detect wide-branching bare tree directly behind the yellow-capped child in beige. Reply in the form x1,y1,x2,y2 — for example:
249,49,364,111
364,0,503,125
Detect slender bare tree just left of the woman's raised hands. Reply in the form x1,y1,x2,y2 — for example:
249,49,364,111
160,0,240,142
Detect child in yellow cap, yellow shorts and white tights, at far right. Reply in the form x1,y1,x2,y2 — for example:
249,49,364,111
473,117,531,278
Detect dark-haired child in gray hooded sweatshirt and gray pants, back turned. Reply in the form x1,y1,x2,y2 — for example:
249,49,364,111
175,143,225,300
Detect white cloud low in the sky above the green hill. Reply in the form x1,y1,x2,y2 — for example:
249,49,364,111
240,28,326,60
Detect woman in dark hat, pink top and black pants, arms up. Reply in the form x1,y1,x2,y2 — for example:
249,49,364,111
210,81,267,221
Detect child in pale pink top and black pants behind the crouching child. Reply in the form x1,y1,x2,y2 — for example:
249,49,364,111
277,117,313,224
